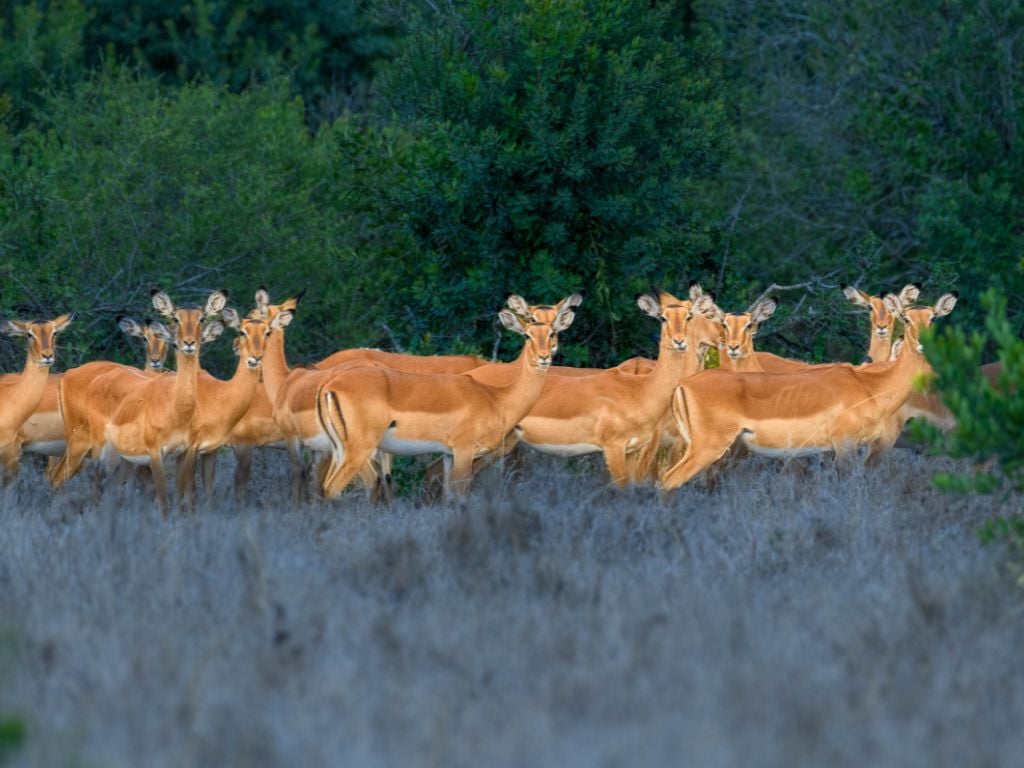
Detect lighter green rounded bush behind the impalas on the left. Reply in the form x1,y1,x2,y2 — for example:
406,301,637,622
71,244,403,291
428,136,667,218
0,72,393,371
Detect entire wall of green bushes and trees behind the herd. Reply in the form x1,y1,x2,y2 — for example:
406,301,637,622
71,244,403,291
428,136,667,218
0,0,1024,370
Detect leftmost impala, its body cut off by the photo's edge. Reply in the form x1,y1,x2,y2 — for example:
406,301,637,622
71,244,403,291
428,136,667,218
0,312,75,488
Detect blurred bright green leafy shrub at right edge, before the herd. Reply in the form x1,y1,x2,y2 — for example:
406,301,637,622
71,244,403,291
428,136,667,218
919,291,1024,492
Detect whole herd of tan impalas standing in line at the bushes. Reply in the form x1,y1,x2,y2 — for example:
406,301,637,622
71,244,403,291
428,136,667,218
0,283,983,516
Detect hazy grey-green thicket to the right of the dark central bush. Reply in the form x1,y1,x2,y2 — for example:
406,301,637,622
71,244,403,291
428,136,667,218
697,0,1024,348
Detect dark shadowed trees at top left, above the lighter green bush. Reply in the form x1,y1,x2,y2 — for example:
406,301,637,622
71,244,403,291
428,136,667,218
0,0,395,122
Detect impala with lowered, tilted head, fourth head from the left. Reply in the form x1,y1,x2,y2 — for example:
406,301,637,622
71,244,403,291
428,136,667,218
178,307,271,506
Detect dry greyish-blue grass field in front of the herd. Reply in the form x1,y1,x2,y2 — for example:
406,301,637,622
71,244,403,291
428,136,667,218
0,451,1024,767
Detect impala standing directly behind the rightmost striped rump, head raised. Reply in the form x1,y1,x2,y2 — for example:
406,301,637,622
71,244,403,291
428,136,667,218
495,283,712,486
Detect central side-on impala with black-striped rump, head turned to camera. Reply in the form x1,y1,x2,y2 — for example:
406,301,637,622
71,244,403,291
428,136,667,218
316,294,582,499
